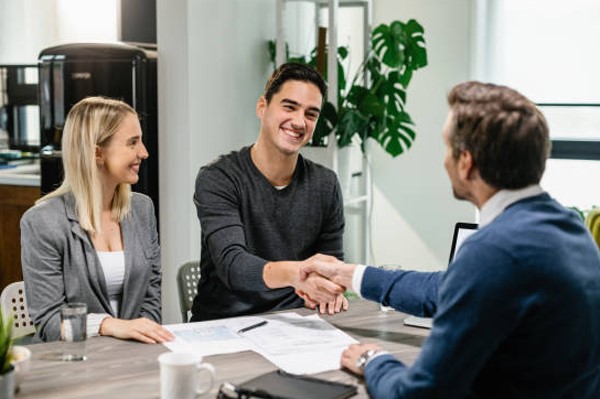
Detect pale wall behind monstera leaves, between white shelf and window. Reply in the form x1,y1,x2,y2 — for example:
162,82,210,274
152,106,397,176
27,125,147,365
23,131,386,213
370,0,475,270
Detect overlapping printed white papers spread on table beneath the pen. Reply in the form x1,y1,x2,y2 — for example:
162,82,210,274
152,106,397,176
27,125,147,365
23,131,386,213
164,312,356,374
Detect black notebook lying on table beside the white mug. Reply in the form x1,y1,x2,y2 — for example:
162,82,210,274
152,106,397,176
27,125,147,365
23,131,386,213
238,370,356,399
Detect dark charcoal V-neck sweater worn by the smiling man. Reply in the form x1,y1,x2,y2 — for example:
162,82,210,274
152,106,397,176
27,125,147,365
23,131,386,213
192,147,344,321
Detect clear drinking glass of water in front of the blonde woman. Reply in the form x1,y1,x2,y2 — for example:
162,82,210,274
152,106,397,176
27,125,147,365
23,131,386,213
60,303,87,361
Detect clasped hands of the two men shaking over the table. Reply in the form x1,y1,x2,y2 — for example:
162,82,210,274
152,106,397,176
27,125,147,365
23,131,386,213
293,254,356,314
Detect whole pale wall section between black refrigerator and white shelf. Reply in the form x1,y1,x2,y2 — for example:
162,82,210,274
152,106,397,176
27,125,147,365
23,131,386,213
157,0,275,323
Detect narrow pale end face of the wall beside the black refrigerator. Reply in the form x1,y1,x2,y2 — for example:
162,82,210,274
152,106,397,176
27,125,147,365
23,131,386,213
156,0,193,323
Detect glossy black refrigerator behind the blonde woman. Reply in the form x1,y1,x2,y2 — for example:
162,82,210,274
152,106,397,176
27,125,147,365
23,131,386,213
38,43,158,220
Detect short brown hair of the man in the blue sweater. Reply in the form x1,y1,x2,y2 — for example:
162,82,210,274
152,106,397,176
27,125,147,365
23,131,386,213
448,82,551,190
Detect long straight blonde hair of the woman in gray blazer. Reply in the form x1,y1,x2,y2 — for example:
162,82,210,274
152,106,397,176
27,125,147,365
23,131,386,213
36,97,137,234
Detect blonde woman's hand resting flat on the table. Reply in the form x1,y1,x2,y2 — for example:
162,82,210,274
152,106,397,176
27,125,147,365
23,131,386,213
100,317,175,344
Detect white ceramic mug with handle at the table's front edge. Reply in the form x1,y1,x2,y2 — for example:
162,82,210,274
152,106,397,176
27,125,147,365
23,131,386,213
158,352,215,399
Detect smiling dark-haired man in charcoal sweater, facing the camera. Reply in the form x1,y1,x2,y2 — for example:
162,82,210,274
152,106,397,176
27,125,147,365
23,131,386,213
192,63,348,321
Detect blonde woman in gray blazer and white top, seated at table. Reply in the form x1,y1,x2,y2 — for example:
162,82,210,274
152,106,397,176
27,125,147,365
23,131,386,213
21,97,172,343
